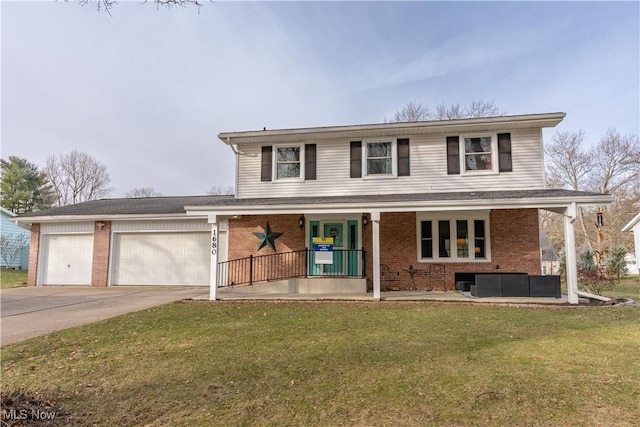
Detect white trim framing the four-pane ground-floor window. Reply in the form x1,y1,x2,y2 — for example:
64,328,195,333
416,210,491,263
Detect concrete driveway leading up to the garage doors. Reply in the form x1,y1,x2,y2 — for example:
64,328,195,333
0,286,209,345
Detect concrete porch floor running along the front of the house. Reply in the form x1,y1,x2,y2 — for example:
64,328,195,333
214,288,576,305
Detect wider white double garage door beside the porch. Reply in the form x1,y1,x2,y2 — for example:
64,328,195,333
111,233,211,286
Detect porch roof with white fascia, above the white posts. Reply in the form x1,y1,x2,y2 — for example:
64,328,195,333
185,189,613,215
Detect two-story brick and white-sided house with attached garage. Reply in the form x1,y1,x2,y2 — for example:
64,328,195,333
15,113,612,303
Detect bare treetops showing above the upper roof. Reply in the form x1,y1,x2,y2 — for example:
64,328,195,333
392,101,506,122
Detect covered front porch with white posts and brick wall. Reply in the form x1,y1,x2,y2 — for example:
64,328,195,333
186,190,611,304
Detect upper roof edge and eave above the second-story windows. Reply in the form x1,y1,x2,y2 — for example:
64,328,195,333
218,113,566,145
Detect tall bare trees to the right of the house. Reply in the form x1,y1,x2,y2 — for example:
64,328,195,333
545,128,640,257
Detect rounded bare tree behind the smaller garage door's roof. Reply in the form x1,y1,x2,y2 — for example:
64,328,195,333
44,150,113,206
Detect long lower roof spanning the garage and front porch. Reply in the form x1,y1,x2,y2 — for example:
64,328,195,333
18,189,613,223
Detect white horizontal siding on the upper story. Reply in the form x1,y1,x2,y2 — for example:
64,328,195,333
237,128,544,198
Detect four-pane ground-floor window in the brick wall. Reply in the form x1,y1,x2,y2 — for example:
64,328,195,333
417,212,490,262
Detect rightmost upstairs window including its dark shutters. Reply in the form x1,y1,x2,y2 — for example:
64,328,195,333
446,133,513,175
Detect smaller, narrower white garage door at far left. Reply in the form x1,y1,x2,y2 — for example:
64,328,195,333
41,234,93,285
